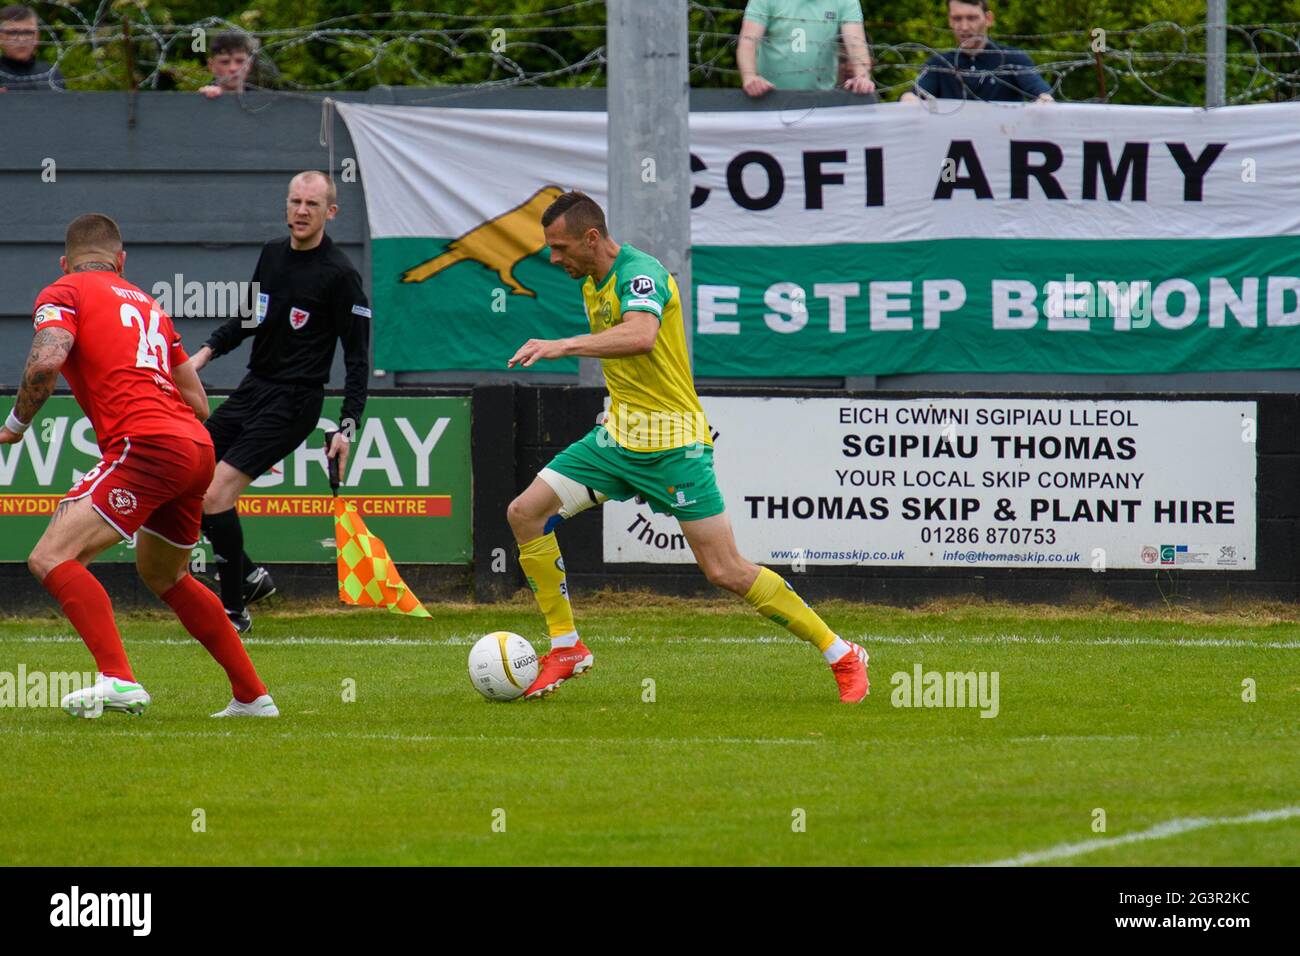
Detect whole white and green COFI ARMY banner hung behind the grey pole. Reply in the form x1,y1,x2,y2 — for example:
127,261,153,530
339,103,1300,377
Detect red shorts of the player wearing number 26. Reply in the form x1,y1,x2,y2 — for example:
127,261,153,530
64,437,216,548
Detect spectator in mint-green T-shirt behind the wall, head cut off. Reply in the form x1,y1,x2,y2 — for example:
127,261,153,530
736,0,876,96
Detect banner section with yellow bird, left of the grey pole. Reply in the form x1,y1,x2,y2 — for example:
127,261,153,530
338,103,606,372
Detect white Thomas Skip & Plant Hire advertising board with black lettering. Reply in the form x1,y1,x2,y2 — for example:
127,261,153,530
603,395,1260,574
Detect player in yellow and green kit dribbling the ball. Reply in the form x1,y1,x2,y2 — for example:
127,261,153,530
507,193,870,704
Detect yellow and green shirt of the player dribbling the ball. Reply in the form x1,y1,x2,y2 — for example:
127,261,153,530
582,243,712,451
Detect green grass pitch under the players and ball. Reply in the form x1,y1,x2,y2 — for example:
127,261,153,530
0,596,1300,866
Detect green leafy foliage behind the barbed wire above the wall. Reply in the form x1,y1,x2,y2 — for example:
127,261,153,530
25,0,1300,105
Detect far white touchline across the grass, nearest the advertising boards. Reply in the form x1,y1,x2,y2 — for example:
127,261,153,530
0,635,1300,650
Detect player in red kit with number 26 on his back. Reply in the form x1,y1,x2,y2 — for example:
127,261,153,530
0,213,280,717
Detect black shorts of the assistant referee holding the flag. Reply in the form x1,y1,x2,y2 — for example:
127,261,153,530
204,375,325,479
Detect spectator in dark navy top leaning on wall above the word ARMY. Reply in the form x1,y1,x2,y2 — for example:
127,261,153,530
900,0,1053,103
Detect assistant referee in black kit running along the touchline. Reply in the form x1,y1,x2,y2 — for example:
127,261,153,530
192,170,371,632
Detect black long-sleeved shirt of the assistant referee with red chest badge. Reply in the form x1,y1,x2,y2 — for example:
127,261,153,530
207,235,371,429
